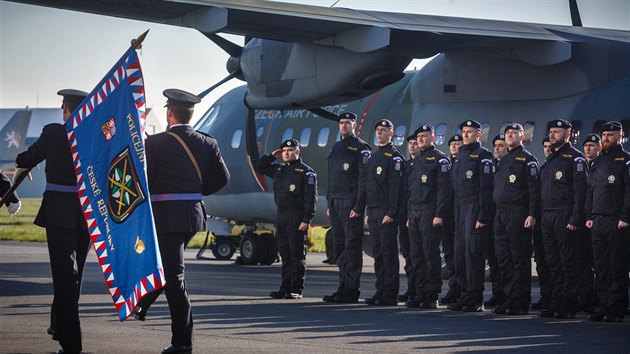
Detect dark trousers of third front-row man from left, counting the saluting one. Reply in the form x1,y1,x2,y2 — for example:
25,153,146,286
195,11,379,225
367,207,400,301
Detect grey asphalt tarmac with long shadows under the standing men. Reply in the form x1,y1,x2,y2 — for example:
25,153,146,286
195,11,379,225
0,241,630,354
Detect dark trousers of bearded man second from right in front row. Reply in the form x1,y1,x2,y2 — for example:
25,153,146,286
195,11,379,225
541,210,579,312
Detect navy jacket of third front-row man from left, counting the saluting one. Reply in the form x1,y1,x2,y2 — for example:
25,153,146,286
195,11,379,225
355,143,405,219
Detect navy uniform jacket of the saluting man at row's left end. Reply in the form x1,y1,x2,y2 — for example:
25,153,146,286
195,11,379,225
256,155,317,224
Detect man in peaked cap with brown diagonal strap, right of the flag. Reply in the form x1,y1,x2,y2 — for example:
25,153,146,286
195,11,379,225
134,89,230,353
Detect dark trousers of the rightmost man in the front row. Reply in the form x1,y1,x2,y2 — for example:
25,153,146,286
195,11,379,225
591,216,630,315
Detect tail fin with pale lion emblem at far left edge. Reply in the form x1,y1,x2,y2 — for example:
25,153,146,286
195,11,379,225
0,110,32,161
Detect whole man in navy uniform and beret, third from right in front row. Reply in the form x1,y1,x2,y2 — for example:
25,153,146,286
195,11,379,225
492,123,540,315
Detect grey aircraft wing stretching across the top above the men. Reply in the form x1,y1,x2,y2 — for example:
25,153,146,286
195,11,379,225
8,0,630,59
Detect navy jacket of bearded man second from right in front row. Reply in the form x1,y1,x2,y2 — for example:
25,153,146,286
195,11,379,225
540,142,587,227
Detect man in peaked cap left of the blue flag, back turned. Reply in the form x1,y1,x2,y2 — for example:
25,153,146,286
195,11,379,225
16,89,90,353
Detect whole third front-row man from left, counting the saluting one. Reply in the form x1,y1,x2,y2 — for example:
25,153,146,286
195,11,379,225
359,119,405,306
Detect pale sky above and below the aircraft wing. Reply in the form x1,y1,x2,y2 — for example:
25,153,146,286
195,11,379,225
0,0,630,124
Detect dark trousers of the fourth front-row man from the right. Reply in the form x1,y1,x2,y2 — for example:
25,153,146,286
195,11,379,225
454,201,489,306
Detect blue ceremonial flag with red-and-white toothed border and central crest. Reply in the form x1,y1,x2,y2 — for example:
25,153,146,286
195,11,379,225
65,48,165,321
